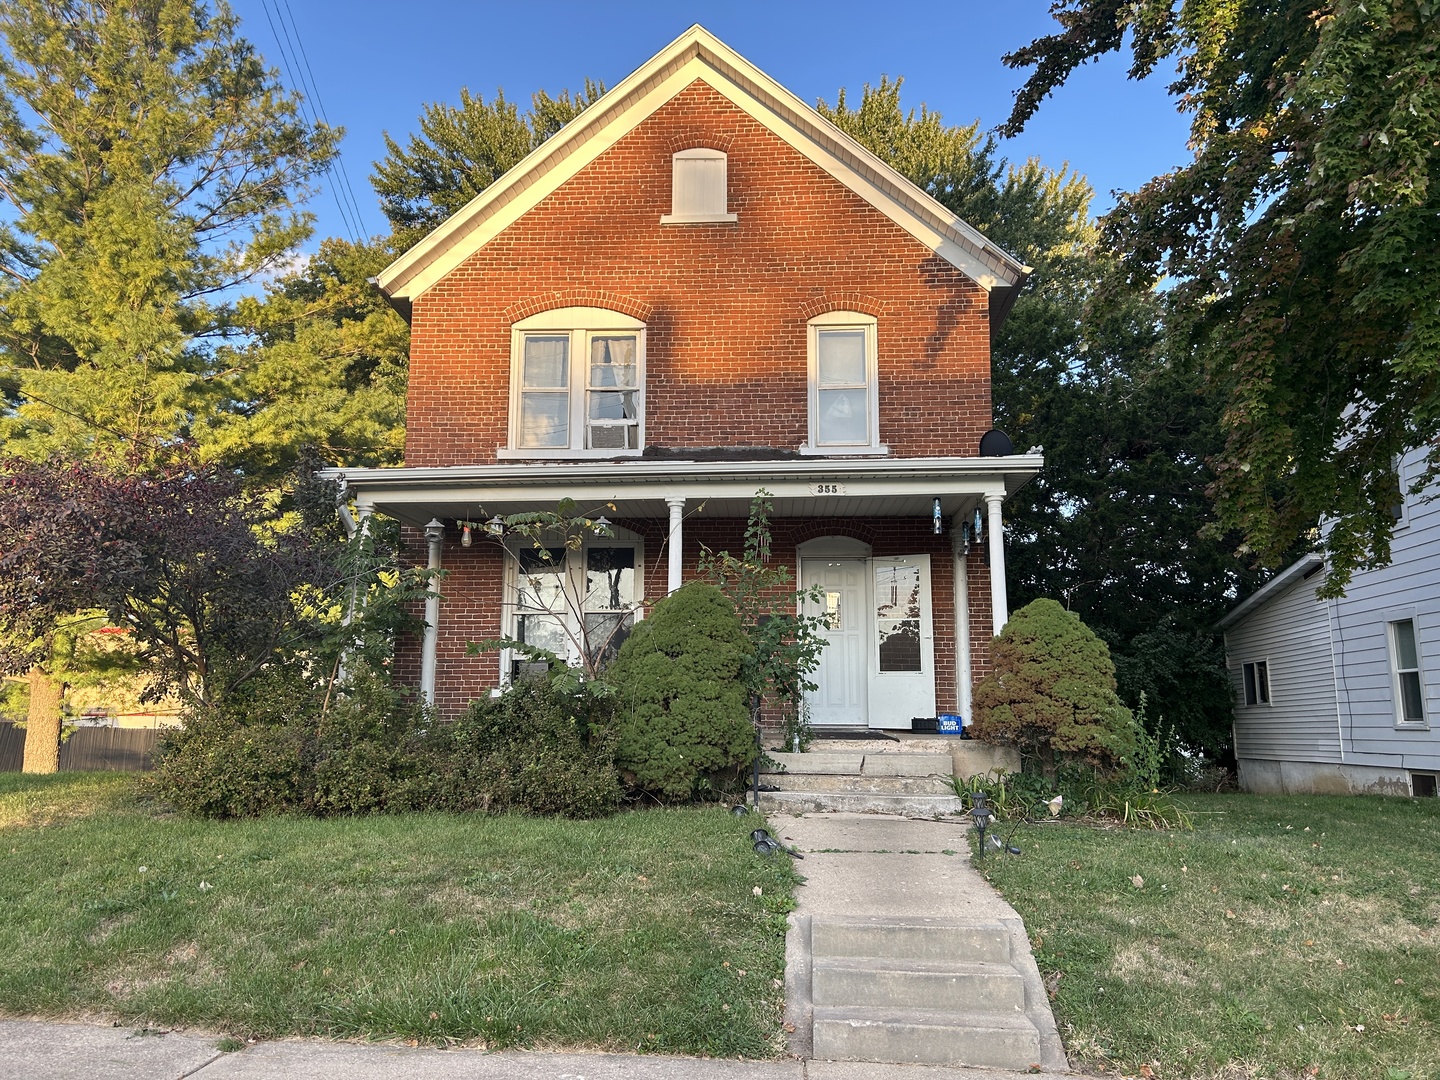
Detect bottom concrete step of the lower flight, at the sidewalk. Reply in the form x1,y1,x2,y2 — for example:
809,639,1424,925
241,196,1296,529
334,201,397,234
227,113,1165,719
814,1005,1043,1071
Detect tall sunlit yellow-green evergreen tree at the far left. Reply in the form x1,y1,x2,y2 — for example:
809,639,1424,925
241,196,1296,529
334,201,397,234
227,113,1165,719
0,0,340,459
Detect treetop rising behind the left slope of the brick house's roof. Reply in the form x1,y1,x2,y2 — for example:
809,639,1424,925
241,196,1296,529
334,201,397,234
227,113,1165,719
370,79,605,251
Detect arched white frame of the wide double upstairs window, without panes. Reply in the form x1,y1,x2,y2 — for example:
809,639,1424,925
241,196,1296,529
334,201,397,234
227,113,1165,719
495,308,645,461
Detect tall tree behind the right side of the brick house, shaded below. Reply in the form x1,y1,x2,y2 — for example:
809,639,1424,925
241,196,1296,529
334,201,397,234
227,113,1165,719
819,79,1256,757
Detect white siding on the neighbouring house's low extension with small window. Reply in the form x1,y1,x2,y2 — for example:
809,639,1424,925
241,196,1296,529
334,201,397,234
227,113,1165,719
1225,570,1341,762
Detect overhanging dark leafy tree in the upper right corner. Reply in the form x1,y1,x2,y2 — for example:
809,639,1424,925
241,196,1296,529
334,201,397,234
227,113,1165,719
1002,0,1440,595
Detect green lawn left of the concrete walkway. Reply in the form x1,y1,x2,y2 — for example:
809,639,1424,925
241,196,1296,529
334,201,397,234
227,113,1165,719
0,773,796,1057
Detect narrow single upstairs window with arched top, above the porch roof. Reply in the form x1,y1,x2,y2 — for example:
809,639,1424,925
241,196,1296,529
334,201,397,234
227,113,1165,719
801,311,887,454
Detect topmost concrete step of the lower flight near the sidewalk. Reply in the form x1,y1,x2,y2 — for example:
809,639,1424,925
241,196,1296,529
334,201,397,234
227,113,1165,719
809,917,1011,963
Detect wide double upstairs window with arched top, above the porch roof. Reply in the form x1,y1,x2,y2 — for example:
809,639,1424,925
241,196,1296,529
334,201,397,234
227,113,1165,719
500,308,645,458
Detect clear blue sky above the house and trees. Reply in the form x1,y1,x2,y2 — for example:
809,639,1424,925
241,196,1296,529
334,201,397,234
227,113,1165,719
232,0,1188,246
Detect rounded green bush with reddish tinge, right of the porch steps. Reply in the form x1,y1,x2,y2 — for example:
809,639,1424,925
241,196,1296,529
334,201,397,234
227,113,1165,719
973,600,1133,773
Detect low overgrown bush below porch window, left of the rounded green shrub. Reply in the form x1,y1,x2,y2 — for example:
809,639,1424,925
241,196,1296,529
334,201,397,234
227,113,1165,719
406,680,621,818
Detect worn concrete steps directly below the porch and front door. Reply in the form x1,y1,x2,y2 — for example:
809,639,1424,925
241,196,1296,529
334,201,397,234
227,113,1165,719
760,742,963,818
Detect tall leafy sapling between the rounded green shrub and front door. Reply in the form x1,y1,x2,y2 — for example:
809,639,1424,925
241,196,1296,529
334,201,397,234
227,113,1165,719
697,490,827,749
